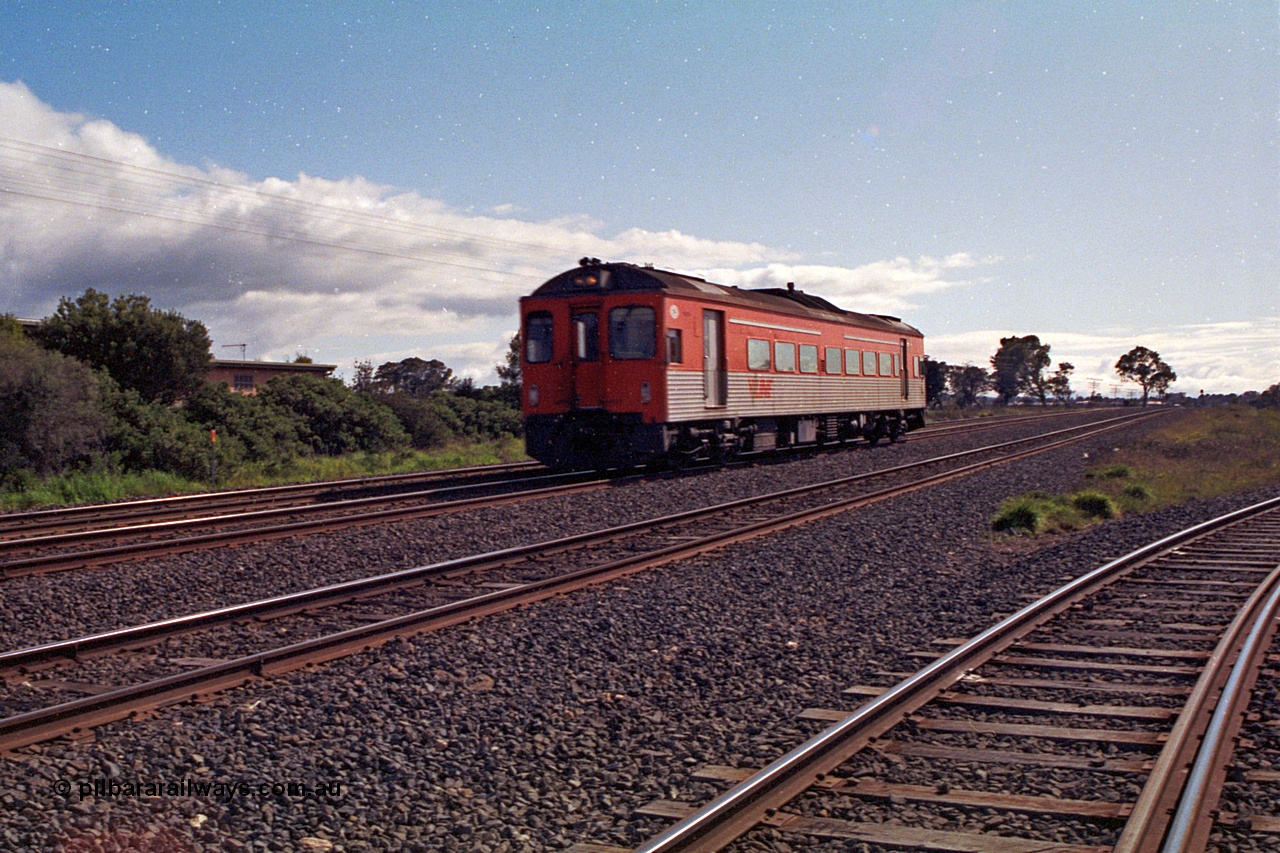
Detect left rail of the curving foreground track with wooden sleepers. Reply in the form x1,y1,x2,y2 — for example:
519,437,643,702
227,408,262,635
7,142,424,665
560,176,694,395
635,498,1280,853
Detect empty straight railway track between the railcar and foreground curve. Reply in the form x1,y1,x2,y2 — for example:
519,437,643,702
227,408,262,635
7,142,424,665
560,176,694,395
0,414,1152,749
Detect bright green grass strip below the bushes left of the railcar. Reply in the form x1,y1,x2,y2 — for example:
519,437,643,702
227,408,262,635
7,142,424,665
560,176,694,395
0,438,529,510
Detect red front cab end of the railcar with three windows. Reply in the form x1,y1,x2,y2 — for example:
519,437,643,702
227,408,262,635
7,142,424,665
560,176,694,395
521,264,668,467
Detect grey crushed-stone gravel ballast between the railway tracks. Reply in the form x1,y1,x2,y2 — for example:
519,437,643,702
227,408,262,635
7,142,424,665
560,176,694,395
0,409,1280,850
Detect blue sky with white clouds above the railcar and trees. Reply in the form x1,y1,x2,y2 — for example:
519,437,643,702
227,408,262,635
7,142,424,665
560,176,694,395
0,0,1280,394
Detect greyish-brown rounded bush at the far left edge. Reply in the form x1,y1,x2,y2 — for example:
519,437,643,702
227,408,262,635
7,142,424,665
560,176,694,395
0,330,108,480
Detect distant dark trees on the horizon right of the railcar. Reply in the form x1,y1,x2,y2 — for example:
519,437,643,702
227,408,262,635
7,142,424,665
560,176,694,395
924,334,1178,409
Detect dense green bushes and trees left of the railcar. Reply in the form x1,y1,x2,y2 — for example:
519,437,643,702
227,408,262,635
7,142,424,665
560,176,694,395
0,289,521,488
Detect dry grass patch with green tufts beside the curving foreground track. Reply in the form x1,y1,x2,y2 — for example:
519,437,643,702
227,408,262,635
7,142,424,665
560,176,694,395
991,406,1280,535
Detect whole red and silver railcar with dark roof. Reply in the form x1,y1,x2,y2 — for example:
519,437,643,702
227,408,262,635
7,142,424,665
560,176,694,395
520,259,924,467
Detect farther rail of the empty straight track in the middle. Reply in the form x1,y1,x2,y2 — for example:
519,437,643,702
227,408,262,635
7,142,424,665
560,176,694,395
0,409,1157,672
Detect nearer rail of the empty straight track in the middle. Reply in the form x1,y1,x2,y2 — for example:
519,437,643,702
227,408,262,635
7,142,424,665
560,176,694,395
0,404,1162,751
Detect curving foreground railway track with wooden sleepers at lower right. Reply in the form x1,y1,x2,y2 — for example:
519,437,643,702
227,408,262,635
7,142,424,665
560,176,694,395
588,498,1280,853
